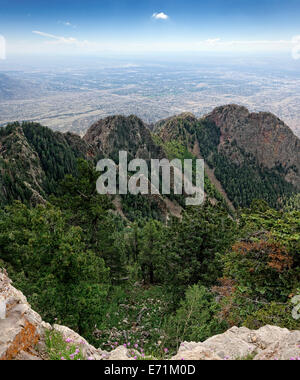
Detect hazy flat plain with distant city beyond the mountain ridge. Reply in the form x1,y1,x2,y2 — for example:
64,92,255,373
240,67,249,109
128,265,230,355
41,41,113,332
0,57,300,136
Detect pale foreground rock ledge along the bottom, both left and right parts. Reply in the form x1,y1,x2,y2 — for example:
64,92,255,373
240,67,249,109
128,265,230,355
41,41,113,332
0,269,300,360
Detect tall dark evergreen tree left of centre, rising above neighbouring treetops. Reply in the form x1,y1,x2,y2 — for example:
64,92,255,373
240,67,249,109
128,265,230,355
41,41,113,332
50,160,126,282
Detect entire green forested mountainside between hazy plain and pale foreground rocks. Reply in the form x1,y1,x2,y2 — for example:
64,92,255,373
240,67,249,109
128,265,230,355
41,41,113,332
0,106,300,358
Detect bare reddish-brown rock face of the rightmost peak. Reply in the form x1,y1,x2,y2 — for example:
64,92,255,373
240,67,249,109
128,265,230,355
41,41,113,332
205,105,300,189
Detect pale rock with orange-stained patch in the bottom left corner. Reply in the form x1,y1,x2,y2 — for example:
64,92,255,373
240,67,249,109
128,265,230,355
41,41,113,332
0,268,146,360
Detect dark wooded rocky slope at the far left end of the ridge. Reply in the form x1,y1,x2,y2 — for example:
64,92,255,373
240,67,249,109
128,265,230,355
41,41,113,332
0,123,95,204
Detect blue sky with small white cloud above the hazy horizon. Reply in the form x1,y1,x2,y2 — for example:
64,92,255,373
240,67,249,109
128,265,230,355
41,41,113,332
0,0,300,57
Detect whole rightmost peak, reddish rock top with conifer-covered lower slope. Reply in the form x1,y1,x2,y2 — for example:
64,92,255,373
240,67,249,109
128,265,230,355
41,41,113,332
154,105,300,207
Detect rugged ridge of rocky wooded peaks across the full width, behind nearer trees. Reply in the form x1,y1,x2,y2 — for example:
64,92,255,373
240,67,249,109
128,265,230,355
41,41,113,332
0,105,300,211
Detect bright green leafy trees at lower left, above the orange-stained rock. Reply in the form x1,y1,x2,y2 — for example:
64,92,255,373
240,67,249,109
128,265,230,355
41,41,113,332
0,202,109,339
